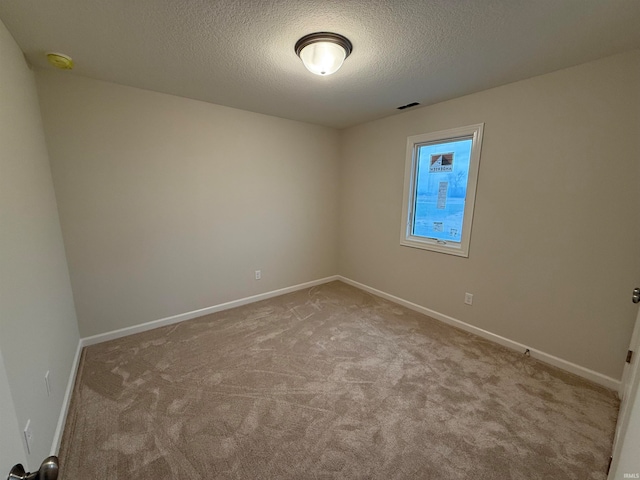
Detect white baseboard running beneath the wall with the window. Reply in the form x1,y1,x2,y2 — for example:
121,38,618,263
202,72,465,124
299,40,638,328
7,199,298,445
338,275,620,391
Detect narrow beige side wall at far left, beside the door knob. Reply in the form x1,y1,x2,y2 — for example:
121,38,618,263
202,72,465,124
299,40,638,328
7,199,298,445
0,17,79,473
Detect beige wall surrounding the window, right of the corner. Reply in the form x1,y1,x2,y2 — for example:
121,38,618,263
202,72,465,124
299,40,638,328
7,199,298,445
339,51,640,379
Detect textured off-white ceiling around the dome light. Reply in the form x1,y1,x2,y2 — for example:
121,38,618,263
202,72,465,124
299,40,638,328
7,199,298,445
0,0,640,127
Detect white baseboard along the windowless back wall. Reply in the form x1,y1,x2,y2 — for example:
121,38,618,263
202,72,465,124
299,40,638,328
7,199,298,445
81,275,340,347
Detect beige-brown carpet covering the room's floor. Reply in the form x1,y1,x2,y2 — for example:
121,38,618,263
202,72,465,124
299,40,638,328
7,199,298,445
60,282,618,480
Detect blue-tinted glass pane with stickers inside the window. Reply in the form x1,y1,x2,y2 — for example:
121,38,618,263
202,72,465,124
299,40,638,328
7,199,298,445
412,137,473,242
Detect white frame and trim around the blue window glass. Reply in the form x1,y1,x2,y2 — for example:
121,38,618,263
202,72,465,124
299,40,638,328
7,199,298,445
400,123,484,257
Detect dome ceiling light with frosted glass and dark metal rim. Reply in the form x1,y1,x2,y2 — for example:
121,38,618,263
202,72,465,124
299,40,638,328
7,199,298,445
295,32,353,76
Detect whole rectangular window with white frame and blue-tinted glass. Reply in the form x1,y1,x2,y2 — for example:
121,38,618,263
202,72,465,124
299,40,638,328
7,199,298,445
400,123,484,257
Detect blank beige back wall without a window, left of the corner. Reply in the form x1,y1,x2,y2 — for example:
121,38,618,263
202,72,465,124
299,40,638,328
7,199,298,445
37,71,339,336
